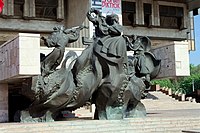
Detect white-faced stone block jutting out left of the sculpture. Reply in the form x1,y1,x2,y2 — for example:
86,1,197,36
0,33,40,82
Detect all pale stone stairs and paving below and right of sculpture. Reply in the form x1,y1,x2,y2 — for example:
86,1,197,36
0,92,200,133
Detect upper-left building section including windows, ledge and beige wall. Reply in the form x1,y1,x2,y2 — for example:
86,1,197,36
0,0,89,47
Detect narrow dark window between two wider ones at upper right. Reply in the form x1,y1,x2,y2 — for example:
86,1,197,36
143,3,152,27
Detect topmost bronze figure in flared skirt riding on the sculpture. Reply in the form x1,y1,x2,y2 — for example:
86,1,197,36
87,8,127,64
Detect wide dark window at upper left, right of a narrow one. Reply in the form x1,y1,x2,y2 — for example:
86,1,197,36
35,0,58,19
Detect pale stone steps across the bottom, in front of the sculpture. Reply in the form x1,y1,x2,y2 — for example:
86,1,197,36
0,117,200,133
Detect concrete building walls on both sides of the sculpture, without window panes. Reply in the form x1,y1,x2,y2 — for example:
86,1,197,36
0,0,195,78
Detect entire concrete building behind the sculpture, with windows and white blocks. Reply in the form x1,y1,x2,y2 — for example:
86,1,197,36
0,0,200,122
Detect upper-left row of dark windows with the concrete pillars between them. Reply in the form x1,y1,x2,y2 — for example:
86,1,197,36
0,0,65,21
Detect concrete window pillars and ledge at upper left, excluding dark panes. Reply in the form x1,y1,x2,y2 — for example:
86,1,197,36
0,0,67,32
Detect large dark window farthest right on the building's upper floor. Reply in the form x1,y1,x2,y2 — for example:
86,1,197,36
159,5,183,29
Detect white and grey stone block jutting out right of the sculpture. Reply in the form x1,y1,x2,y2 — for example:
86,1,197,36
153,42,190,78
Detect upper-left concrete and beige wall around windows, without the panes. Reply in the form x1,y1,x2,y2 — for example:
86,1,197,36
0,0,89,47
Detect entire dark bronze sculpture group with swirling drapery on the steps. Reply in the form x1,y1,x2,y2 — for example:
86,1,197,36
21,8,160,121
